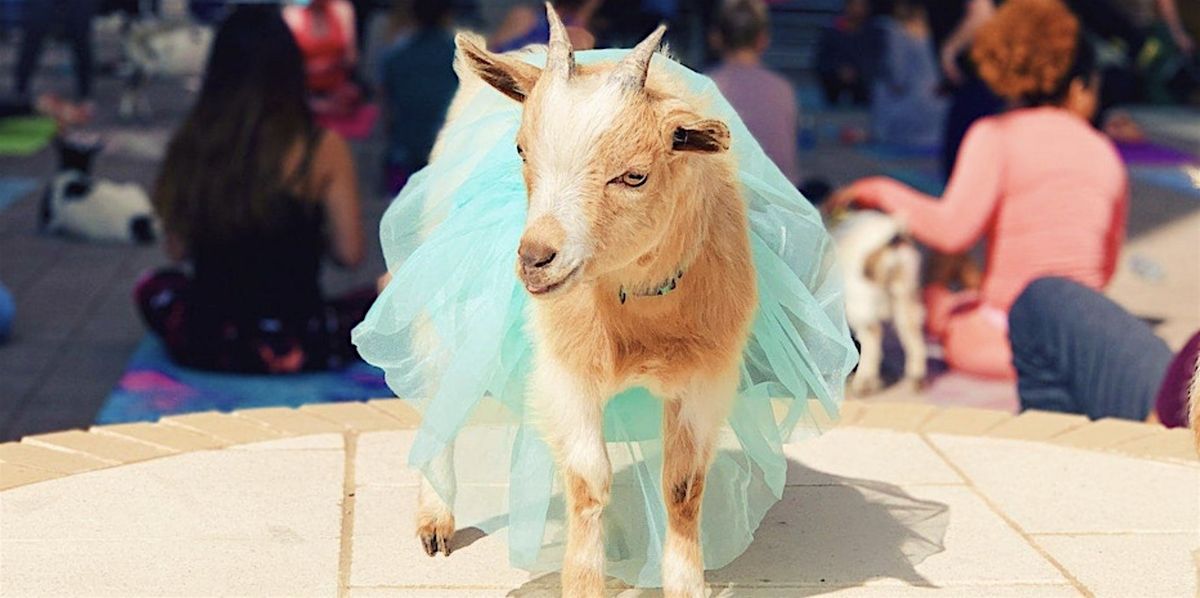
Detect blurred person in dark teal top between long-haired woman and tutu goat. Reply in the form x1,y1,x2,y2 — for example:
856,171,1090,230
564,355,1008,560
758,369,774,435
379,0,458,195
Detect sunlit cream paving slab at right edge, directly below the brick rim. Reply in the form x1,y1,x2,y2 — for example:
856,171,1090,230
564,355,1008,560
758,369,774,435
929,435,1200,533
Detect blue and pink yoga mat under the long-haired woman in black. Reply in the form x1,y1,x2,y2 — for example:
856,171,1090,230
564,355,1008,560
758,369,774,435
96,335,392,424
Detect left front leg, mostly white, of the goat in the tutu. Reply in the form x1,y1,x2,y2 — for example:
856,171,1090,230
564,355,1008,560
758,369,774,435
530,361,612,598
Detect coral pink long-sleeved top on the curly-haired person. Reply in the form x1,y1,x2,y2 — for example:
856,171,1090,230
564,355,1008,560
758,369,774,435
856,107,1129,313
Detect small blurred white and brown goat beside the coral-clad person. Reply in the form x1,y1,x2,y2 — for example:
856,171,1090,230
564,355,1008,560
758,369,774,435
832,211,926,396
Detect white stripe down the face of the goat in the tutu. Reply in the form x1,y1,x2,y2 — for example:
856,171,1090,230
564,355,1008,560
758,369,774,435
528,80,624,262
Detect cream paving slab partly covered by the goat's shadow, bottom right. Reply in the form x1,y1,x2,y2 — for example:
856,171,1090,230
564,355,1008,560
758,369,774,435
707,482,1068,590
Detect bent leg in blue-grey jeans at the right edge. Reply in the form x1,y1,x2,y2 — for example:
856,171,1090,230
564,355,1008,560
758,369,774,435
1008,277,1200,427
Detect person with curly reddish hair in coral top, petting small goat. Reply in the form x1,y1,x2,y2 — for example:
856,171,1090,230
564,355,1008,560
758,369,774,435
829,0,1129,379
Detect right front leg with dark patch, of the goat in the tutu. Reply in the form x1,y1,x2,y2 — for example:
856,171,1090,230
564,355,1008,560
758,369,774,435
662,372,738,598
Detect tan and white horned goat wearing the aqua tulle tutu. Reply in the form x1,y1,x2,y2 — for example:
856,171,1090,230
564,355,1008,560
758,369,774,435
418,6,757,597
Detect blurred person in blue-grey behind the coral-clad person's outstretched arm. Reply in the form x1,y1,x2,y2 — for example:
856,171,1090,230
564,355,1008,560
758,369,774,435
871,0,947,148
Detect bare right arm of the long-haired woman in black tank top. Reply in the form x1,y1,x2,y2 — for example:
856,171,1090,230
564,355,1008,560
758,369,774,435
313,131,364,268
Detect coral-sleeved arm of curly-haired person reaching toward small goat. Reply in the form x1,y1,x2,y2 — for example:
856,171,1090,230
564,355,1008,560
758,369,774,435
834,120,1003,253
